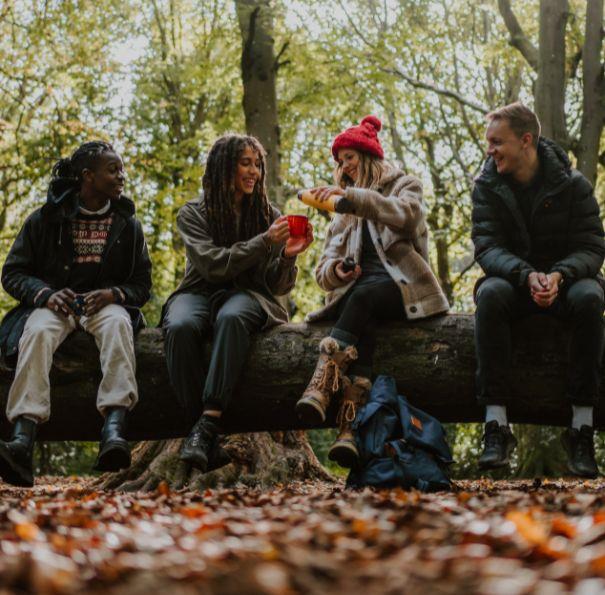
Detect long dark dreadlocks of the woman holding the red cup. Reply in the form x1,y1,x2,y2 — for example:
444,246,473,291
202,133,271,247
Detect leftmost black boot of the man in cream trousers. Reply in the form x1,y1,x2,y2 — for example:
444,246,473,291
0,417,37,488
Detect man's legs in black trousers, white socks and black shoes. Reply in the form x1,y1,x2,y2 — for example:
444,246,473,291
475,277,605,477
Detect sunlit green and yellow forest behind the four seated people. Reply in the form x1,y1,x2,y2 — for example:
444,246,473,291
0,0,605,476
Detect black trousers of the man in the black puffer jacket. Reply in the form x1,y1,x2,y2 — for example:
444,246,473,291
475,277,605,405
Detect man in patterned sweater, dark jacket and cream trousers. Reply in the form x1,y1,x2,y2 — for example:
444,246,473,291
0,141,151,486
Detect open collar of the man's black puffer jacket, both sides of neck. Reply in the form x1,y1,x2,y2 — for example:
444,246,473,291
475,136,571,191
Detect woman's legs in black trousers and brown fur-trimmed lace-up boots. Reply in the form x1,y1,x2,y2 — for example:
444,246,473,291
296,277,404,467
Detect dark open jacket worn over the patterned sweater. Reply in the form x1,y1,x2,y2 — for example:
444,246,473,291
0,179,151,364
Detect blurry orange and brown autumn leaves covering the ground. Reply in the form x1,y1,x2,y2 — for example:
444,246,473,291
0,479,605,595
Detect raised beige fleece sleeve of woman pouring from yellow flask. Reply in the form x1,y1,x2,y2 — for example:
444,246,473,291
345,176,424,238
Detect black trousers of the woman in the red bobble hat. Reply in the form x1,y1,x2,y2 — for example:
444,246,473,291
330,277,405,378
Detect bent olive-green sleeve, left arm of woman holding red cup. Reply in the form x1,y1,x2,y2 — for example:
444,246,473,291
177,203,269,283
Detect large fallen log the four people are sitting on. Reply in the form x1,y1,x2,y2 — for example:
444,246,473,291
0,314,605,440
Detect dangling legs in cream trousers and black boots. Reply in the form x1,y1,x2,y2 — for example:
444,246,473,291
0,304,138,487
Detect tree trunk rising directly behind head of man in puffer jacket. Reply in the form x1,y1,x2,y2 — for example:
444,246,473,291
536,0,569,147
